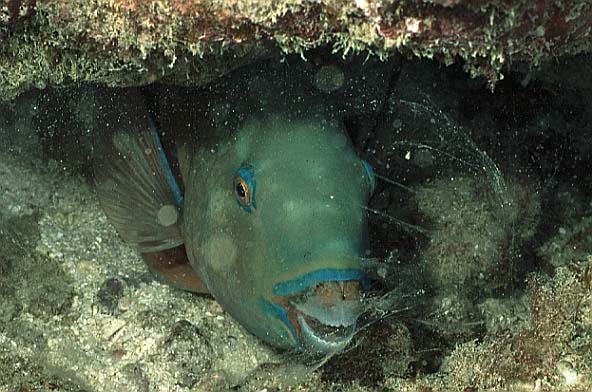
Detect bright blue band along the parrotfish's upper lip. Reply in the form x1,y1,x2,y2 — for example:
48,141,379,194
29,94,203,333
273,268,369,295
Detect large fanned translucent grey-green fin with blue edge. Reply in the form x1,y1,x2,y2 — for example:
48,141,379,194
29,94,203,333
93,91,183,252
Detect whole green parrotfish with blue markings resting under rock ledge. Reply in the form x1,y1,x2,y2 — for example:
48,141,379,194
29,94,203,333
94,71,374,355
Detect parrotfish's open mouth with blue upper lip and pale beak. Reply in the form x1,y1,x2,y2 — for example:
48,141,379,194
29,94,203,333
274,270,365,355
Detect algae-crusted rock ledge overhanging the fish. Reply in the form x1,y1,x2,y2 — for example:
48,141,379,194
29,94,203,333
0,0,592,100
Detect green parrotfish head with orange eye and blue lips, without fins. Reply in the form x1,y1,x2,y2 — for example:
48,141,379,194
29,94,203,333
187,118,374,354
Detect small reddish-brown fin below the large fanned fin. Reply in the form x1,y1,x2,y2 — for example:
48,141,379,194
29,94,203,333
142,245,210,294
